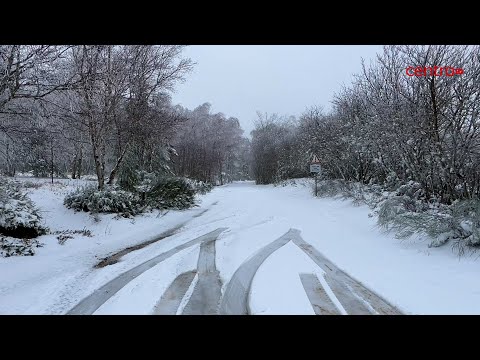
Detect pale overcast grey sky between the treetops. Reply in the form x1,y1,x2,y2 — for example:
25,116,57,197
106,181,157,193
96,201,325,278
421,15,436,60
173,45,382,135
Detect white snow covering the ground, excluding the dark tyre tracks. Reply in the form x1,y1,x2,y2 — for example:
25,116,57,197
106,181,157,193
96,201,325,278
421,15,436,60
0,179,480,314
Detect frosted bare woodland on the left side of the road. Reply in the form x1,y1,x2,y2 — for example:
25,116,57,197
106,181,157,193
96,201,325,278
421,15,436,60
0,45,249,190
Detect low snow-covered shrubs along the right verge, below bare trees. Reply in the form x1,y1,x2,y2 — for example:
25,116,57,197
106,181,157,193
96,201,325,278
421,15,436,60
318,179,480,255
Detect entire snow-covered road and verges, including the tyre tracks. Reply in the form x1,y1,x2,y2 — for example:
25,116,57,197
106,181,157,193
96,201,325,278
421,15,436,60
0,182,480,315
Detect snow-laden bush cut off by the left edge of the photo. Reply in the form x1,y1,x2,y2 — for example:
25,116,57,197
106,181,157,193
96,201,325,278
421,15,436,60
0,179,48,239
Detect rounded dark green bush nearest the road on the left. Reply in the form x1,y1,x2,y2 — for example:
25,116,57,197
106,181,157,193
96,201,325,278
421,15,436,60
147,177,195,209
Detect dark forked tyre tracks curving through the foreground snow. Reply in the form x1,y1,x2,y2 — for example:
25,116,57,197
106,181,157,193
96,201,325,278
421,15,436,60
67,222,401,315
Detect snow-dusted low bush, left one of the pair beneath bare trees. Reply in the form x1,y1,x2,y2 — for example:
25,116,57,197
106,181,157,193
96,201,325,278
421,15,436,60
63,186,143,217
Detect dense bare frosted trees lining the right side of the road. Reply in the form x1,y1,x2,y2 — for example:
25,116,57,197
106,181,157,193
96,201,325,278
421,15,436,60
252,45,480,204
